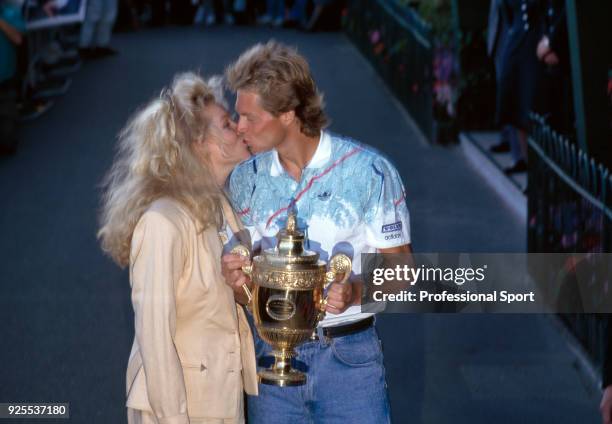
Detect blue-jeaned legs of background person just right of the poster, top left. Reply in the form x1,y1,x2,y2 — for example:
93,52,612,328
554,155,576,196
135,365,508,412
79,0,118,59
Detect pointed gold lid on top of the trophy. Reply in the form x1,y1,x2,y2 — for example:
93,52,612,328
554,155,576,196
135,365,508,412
264,210,319,265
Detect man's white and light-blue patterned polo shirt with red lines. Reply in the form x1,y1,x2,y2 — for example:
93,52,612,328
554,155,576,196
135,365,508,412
229,131,410,326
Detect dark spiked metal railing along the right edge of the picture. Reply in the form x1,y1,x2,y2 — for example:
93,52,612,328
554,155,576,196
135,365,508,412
528,114,612,384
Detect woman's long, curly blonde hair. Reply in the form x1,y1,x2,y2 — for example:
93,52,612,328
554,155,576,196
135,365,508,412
98,72,225,267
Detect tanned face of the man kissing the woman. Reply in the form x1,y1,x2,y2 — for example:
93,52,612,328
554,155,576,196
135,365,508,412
236,90,287,154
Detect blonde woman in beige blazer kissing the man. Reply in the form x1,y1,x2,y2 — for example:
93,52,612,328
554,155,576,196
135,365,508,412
99,73,257,424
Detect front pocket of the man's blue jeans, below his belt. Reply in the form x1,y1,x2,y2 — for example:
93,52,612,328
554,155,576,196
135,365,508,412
331,328,382,367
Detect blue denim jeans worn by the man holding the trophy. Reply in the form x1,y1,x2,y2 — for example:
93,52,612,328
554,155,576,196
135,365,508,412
248,327,390,424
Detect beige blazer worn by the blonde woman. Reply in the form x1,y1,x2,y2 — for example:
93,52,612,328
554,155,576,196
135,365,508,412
127,198,257,424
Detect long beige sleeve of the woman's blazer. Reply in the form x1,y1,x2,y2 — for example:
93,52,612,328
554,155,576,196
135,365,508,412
131,211,189,424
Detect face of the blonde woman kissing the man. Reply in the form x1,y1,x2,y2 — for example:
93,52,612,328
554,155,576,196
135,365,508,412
204,103,251,167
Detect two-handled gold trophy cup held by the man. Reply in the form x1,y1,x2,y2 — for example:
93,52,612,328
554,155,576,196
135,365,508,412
232,213,352,387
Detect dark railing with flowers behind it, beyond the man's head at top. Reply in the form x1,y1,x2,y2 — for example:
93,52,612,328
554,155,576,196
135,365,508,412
344,0,434,140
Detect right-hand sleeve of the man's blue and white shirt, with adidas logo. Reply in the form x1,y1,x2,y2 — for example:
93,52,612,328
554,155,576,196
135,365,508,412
365,157,410,249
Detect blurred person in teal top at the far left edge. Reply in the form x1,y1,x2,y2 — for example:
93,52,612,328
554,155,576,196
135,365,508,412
0,0,25,154
